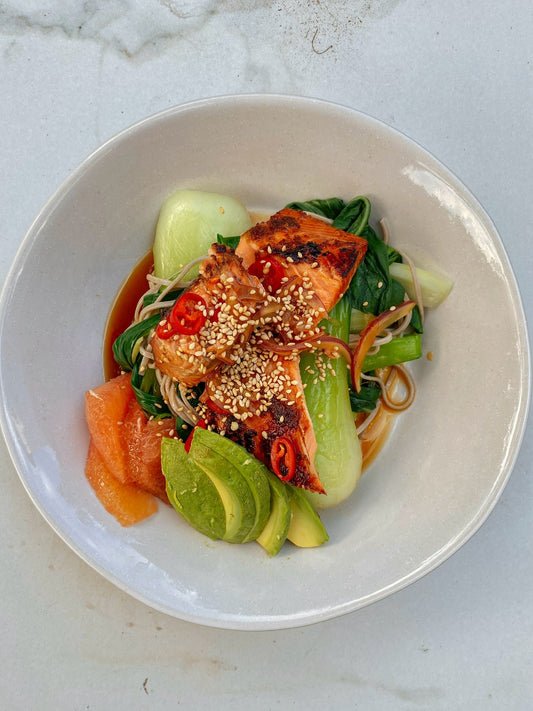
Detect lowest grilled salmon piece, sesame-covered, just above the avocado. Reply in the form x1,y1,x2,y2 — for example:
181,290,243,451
201,337,326,494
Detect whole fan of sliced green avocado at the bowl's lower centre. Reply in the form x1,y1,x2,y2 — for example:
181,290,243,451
161,428,328,556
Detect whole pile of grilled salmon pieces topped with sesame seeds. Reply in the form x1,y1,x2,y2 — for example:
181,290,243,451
151,208,367,493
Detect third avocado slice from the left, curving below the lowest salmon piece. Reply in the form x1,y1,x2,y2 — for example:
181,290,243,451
191,429,270,543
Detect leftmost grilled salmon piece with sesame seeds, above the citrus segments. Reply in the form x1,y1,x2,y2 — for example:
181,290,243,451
150,244,267,387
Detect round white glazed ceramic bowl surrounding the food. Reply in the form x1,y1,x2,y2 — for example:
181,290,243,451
0,95,529,629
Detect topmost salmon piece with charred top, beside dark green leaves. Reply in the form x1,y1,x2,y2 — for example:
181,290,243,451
235,208,367,311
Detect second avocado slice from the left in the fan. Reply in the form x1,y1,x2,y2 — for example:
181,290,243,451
189,428,256,543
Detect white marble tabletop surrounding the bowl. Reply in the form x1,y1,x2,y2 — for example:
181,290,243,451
0,0,533,711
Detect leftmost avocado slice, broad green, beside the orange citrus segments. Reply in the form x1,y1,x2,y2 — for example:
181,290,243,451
161,437,226,540
